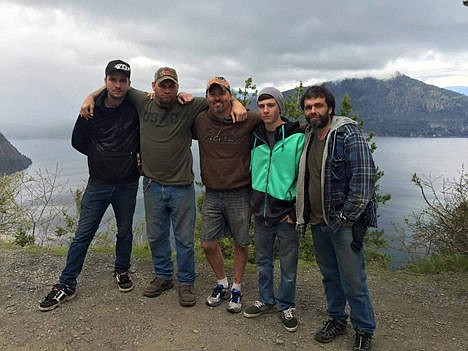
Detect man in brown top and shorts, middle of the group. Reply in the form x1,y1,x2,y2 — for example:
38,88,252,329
194,77,260,313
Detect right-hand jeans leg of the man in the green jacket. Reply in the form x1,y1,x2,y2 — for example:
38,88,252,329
275,221,299,311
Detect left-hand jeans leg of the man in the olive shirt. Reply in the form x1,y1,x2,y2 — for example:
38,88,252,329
143,177,174,280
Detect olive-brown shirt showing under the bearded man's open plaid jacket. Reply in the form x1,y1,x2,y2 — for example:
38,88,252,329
307,135,326,225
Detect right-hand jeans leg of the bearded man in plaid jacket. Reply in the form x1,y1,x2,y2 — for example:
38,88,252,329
333,227,376,334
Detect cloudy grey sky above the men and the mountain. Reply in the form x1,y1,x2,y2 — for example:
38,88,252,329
0,0,468,138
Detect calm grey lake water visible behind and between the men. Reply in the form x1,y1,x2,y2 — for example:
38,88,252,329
12,137,468,264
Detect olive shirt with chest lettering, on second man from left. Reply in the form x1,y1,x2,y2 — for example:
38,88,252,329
129,89,208,185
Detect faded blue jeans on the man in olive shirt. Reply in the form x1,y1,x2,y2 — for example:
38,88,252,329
143,177,196,285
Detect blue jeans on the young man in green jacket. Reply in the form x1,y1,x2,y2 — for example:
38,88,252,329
255,219,299,311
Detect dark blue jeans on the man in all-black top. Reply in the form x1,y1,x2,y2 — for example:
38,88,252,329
59,181,138,288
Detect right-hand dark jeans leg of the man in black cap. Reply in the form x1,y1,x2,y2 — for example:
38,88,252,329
111,181,138,270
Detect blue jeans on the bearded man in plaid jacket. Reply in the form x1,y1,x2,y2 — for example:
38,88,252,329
312,224,375,334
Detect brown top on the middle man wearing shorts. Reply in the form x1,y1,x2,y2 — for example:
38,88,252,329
194,110,260,190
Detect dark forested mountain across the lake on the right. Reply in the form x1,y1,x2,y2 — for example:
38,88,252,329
284,74,468,138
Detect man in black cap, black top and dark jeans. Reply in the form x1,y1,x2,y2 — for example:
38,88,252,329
39,60,140,311
